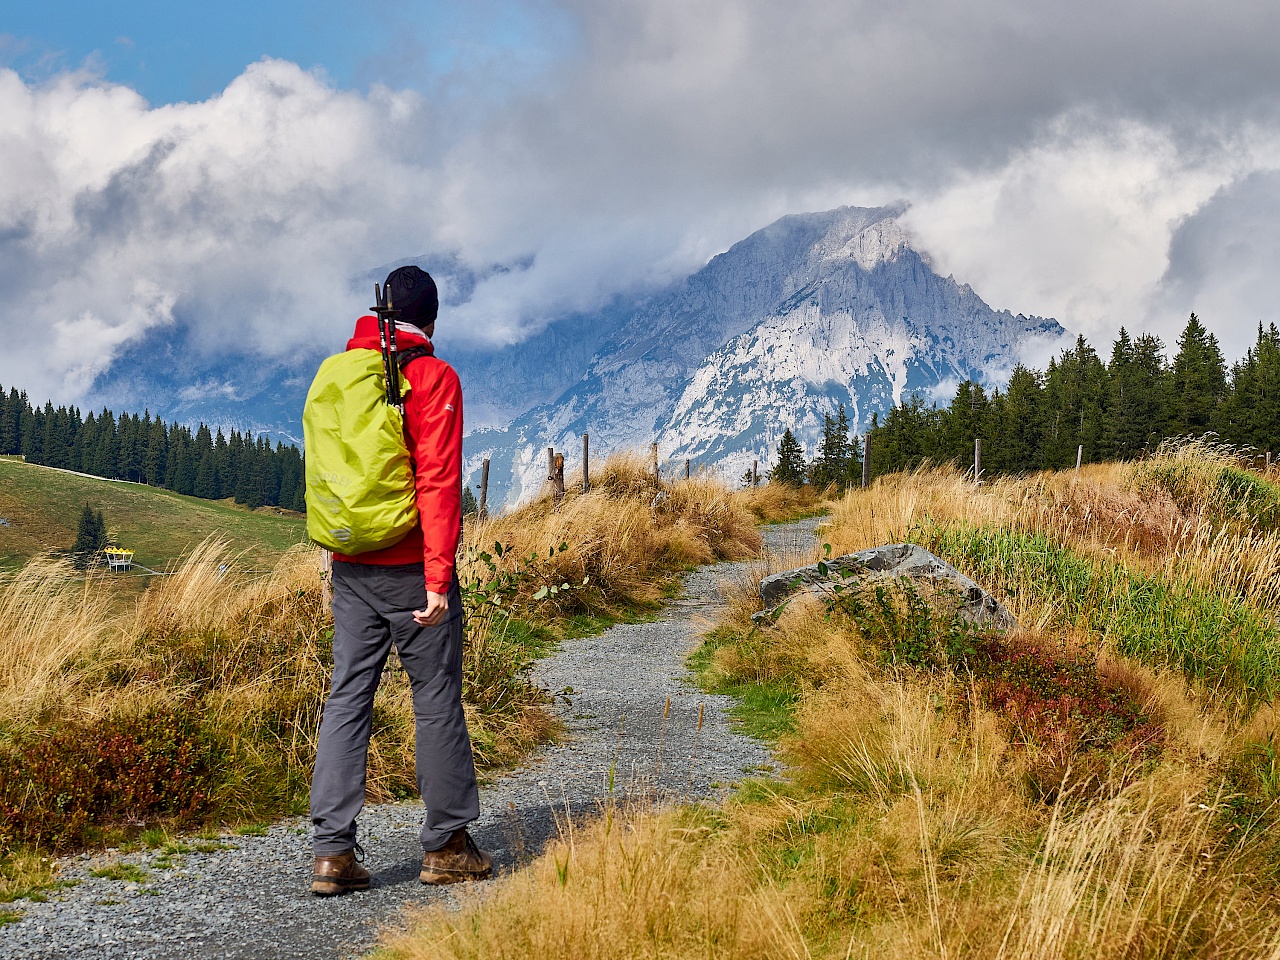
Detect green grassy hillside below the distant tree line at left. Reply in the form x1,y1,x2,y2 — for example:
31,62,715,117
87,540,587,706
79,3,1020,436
0,458,306,570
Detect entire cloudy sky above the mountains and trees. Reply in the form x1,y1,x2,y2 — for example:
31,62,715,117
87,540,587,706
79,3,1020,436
0,0,1280,401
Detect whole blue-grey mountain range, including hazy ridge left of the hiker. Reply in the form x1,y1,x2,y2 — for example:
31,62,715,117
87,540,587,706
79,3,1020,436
85,205,1066,504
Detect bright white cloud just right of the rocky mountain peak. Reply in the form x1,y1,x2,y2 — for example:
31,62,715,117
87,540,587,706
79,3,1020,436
908,111,1280,346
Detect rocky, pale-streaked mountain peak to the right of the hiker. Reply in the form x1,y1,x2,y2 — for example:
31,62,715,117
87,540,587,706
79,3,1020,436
467,206,1066,502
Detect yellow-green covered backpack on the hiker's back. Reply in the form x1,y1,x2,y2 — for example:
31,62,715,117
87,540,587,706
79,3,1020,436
302,349,417,556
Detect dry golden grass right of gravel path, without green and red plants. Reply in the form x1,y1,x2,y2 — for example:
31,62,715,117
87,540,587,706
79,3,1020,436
380,451,1280,960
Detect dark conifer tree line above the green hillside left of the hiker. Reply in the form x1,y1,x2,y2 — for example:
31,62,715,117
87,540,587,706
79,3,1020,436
0,387,306,511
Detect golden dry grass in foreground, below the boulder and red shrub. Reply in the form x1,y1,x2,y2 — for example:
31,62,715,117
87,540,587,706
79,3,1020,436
379,604,1280,960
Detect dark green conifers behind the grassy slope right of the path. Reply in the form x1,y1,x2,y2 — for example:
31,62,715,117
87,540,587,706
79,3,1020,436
769,320,1280,486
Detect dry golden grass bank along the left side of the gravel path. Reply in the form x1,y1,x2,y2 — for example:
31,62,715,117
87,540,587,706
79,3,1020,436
0,457,760,846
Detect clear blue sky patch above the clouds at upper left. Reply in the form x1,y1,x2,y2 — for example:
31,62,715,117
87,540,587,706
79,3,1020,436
0,0,571,105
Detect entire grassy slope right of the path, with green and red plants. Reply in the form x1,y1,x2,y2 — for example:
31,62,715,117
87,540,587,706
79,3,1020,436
380,444,1280,960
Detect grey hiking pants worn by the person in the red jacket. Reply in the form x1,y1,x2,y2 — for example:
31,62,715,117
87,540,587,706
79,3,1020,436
311,562,480,856
